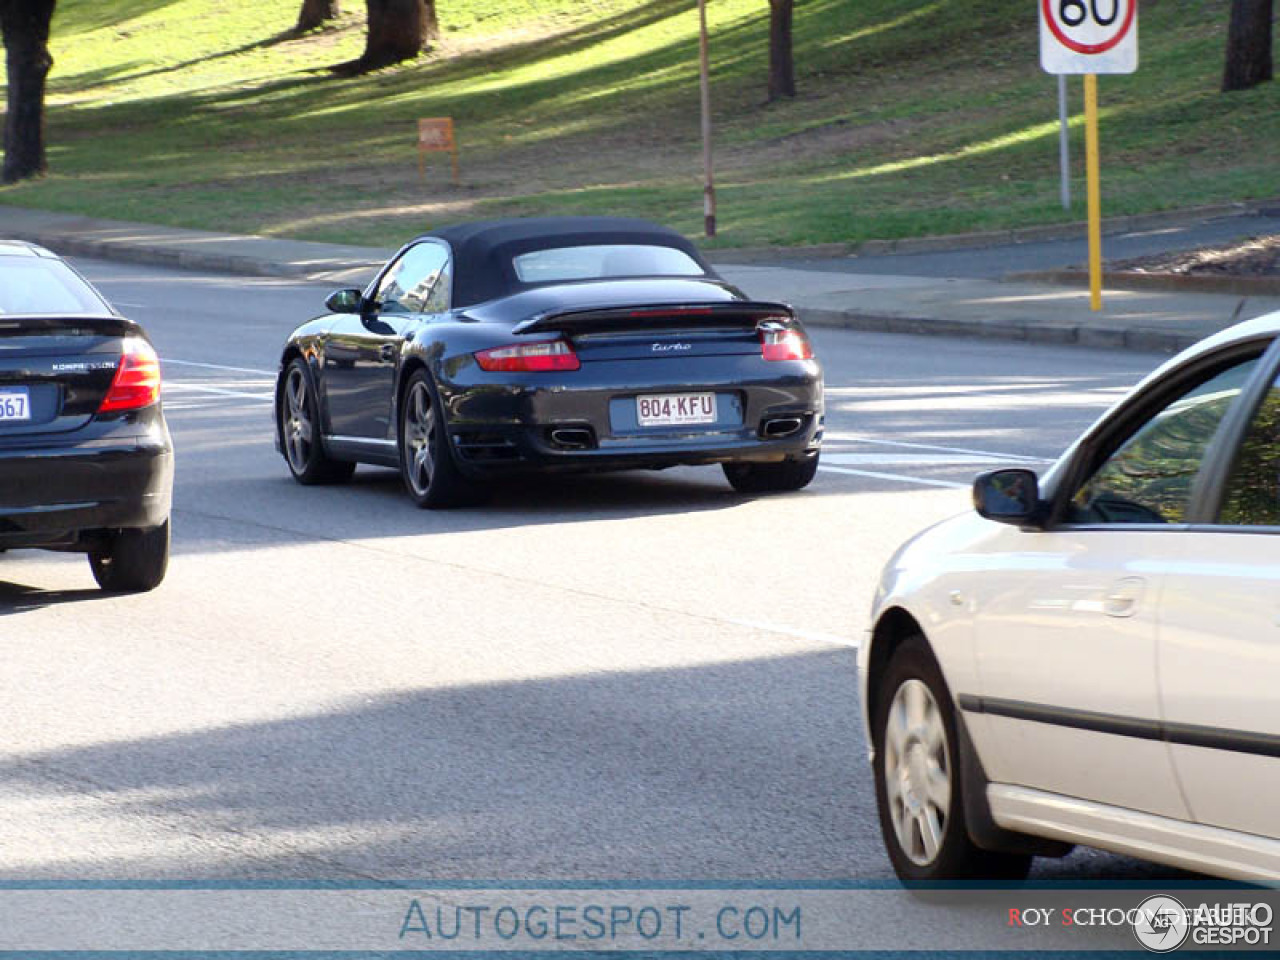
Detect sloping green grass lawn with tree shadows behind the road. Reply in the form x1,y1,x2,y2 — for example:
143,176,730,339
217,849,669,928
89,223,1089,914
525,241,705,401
0,0,1280,246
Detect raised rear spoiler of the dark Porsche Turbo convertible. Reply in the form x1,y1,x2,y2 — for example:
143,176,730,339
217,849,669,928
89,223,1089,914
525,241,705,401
512,300,796,334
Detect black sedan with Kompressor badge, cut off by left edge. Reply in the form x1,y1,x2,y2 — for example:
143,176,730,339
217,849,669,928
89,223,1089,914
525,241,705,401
0,241,173,591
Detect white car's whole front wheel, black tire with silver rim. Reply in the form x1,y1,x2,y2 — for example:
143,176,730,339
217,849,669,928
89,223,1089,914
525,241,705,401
872,635,1032,886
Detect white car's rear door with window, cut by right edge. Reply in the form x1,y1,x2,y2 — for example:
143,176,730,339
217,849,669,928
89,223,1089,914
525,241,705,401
1160,340,1280,838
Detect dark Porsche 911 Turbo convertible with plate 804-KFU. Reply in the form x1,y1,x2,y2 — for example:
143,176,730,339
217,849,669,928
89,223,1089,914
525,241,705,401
275,218,823,507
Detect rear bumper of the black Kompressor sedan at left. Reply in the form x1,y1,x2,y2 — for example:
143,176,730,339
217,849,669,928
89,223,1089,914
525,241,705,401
0,426,173,549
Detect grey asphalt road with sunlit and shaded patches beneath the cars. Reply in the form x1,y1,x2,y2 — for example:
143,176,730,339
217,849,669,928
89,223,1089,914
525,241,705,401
0,262,1192,882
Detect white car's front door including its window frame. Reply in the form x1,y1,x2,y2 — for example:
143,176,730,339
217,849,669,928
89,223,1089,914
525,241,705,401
974,347,1262,819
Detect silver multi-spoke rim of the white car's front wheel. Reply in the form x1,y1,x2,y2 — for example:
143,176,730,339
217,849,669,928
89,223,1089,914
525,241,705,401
884,678,951,867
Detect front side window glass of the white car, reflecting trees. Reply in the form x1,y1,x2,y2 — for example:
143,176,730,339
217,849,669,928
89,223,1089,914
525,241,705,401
1068,358,1258,524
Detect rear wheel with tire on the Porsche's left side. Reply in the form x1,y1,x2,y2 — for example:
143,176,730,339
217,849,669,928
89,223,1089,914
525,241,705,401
397,370,484,509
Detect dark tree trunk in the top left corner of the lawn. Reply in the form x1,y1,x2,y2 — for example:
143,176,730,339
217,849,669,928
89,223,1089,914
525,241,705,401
0,0,55,183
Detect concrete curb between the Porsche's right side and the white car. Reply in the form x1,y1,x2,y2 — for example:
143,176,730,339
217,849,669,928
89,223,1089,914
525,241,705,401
797,307,1203,353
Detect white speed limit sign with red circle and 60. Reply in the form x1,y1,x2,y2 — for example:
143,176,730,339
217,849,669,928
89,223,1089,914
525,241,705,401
1039,0,1138,73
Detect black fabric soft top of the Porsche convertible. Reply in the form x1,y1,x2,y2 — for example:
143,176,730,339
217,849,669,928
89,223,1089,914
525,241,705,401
424,216,716,307
